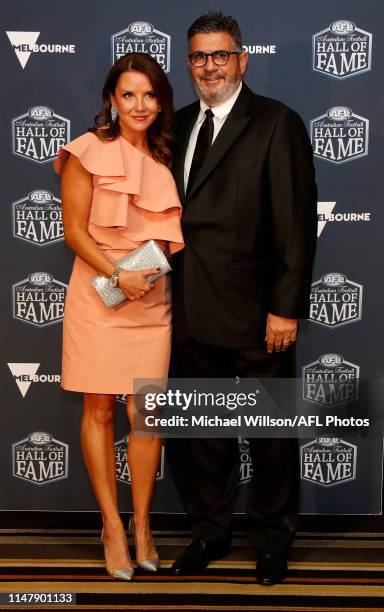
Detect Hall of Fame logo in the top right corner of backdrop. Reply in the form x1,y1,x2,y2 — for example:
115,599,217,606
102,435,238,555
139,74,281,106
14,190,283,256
312,19,372,79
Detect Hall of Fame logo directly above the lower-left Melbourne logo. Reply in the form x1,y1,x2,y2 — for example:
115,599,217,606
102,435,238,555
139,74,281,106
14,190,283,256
12,272,67,327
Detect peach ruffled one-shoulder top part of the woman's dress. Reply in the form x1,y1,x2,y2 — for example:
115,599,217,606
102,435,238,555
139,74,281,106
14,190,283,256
54,132,184,253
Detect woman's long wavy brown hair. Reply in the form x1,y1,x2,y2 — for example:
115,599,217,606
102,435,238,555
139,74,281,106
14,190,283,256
88,53,175,167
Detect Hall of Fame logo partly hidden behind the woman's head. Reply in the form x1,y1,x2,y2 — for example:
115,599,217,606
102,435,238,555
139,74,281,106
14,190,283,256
111,21,171,72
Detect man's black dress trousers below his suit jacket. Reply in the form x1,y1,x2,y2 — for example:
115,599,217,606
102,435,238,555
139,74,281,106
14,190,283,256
176,338,299,552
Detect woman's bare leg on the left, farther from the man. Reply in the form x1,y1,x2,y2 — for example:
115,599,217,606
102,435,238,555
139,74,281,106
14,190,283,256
81,393,132,573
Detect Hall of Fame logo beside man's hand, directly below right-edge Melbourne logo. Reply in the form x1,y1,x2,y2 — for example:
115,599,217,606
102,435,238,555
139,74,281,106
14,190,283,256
309,272,363,327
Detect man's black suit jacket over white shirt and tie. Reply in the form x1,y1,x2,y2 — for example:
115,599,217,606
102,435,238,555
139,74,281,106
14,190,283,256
173,83,317,348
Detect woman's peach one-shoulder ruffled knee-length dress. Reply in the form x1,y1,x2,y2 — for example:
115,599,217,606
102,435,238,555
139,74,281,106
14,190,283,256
54,133,183,394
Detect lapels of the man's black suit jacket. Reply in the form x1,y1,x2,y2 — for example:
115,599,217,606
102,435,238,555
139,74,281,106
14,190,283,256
187,83,252,200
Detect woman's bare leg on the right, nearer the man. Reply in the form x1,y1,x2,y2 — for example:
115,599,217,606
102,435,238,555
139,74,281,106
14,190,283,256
127,395,162,560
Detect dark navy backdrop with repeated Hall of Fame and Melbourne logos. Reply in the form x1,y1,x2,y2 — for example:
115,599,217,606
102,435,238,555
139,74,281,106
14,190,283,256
0,0,384,514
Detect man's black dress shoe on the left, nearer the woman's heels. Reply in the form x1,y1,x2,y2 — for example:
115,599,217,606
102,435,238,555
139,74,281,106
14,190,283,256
171,539,230,576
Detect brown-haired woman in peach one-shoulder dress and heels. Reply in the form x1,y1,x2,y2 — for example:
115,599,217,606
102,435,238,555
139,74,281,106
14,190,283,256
55,53,183,580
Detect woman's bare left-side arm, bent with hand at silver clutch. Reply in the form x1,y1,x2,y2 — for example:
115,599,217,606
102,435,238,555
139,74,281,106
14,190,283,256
61,154,156,300
